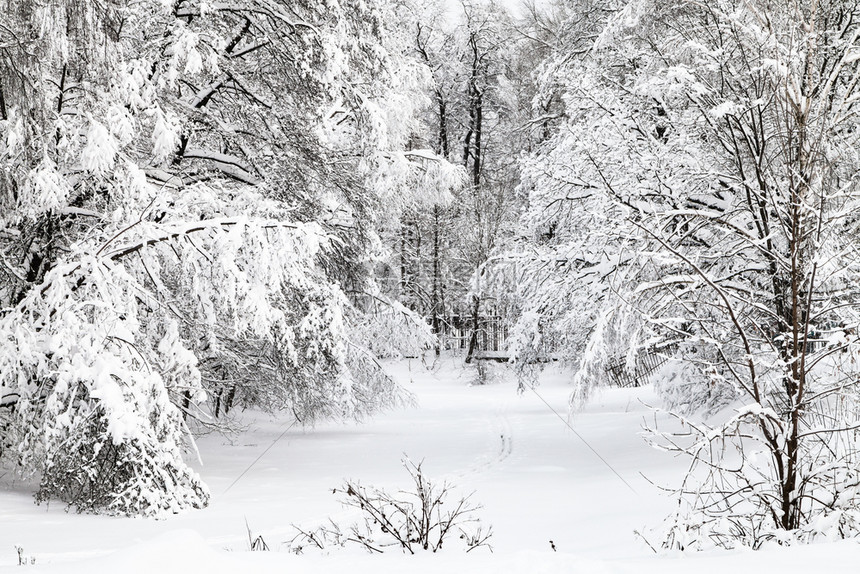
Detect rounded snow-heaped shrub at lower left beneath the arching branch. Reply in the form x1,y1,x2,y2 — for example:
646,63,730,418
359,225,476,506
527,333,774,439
0,258,209,515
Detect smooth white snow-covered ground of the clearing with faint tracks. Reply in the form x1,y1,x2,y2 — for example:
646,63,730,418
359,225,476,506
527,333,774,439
0,357,860,574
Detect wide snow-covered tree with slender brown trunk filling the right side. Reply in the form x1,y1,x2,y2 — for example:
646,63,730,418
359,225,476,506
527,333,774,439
510,0,860,548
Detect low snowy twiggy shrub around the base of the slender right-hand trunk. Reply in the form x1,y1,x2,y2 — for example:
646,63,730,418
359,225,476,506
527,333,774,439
655,390,860,550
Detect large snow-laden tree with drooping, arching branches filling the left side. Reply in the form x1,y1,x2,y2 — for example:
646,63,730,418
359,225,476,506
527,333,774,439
0,0,445,514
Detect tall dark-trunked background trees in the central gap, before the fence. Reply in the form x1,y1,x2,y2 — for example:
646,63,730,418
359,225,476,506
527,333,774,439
384,1,523,355
